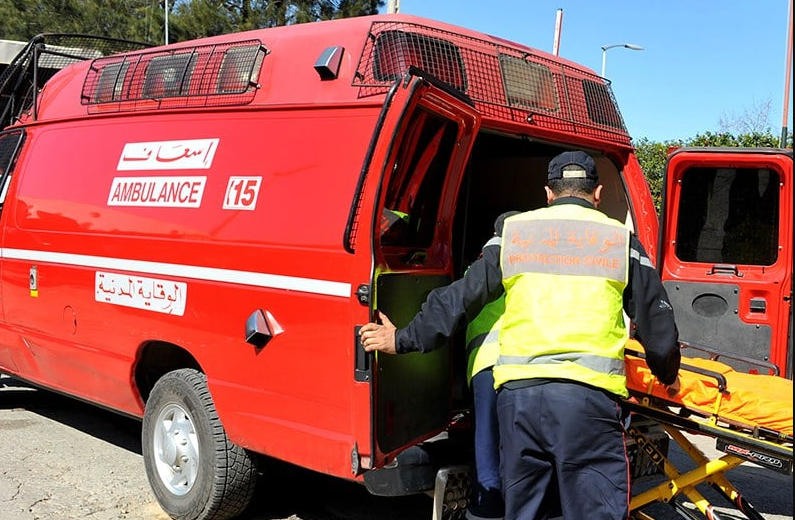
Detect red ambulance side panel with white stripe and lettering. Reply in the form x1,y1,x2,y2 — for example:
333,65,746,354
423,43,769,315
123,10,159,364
0,109,378,475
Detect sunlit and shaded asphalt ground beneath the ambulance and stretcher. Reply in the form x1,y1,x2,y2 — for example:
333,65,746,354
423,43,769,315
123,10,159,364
0,376,793,520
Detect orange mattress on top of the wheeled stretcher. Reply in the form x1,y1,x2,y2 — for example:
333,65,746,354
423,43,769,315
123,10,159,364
625,340,793,437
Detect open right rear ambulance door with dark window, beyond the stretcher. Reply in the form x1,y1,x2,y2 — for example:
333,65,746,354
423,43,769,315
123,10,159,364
659,148,793,379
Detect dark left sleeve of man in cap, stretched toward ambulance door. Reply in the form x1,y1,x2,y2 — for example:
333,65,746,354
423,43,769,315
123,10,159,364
395,240,503,354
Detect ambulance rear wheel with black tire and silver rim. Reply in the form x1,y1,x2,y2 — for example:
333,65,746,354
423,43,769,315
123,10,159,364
141,369,257,520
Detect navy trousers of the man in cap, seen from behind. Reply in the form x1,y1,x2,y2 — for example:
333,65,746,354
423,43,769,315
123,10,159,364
497,381,630,520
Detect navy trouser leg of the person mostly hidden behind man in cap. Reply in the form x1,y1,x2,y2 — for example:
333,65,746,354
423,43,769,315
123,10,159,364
467,369,505,518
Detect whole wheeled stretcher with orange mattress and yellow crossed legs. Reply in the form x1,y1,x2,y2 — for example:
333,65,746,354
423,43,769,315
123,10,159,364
625,341,793,520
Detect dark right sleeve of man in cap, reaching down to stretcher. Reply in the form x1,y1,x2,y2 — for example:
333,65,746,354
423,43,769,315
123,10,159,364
624,235,681,385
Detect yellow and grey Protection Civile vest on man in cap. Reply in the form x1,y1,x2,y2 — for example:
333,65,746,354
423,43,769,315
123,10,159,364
494,204,630,396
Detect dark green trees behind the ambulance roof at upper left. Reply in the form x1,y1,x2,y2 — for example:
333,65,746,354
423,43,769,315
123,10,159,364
0,0,384,44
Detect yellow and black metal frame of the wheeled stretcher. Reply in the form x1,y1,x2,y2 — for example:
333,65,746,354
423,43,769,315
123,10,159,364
625,342,793,520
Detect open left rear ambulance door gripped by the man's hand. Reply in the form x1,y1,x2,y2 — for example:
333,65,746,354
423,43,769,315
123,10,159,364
368,68,480,467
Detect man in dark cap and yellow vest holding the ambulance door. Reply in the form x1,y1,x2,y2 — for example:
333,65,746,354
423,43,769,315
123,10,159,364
360,151,680,520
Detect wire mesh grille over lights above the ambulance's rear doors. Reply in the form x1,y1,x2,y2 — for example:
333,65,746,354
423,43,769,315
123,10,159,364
353,22,630,144
